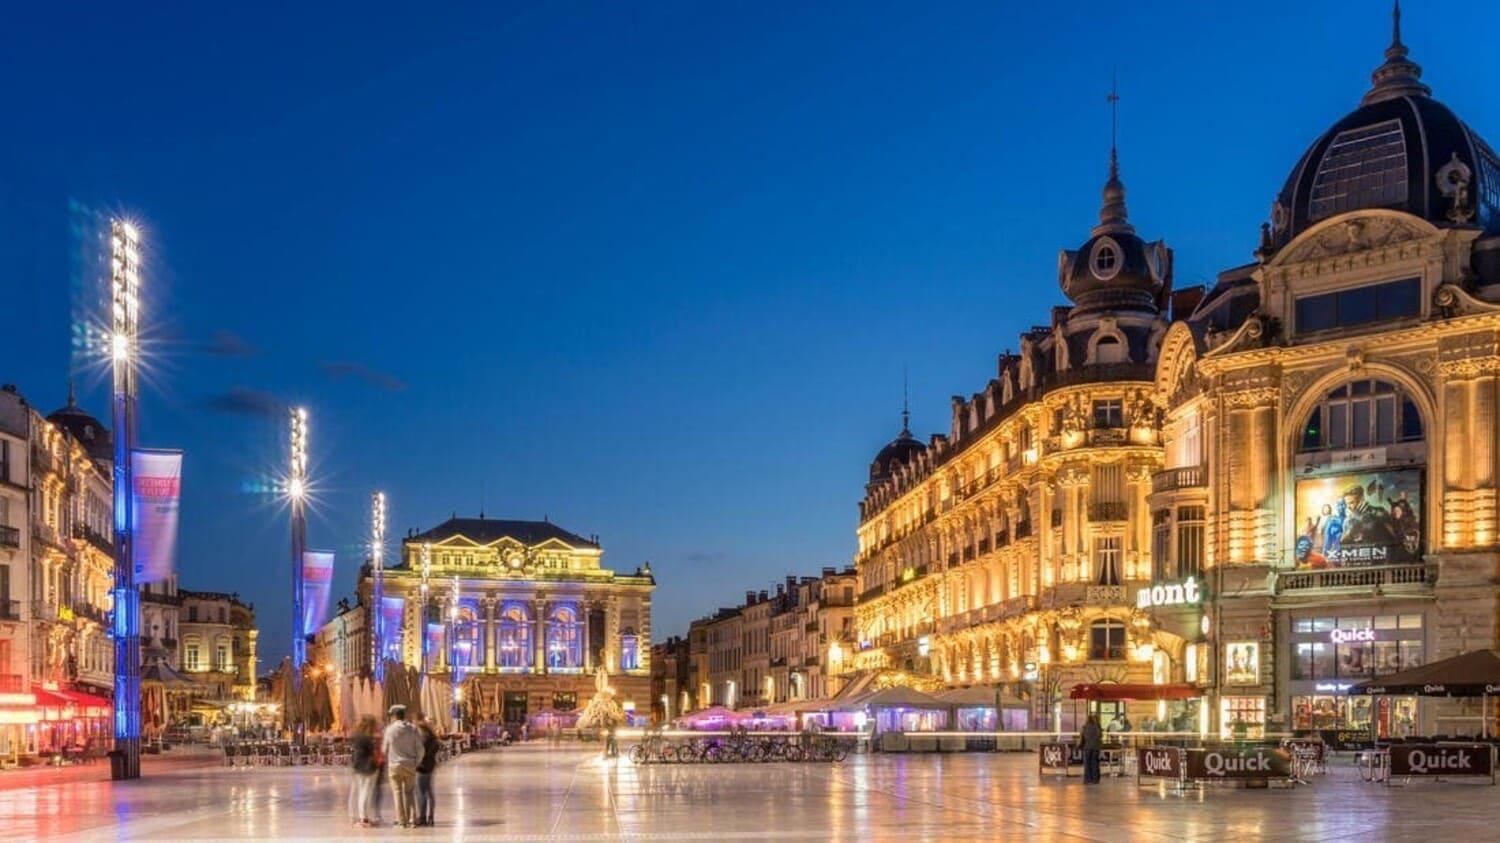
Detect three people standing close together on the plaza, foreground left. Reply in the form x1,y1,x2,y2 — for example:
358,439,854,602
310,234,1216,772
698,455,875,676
350,705,443,828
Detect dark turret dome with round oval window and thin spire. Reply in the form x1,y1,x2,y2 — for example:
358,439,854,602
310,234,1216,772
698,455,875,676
1058,149,1172,314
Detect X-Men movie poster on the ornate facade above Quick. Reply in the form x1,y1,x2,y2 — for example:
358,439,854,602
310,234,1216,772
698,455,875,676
1295,468,1422,569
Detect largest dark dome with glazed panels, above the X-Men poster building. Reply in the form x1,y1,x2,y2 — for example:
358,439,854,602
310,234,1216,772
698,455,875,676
1271,3,1500,248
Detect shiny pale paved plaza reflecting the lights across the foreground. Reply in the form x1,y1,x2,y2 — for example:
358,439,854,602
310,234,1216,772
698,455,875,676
0,746,1500,843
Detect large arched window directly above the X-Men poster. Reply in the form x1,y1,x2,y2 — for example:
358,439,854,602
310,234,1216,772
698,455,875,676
1298,380,1422,453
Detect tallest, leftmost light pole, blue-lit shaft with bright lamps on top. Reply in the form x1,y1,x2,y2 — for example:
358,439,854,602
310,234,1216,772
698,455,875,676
110,219,141,780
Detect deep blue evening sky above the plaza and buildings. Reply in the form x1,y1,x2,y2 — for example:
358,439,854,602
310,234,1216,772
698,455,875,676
0,0,1500,666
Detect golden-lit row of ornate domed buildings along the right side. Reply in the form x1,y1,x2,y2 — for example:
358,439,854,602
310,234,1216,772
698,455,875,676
851,11,1500,735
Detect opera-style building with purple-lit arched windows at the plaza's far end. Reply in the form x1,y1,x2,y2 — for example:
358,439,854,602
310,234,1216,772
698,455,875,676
360,518,656,723
